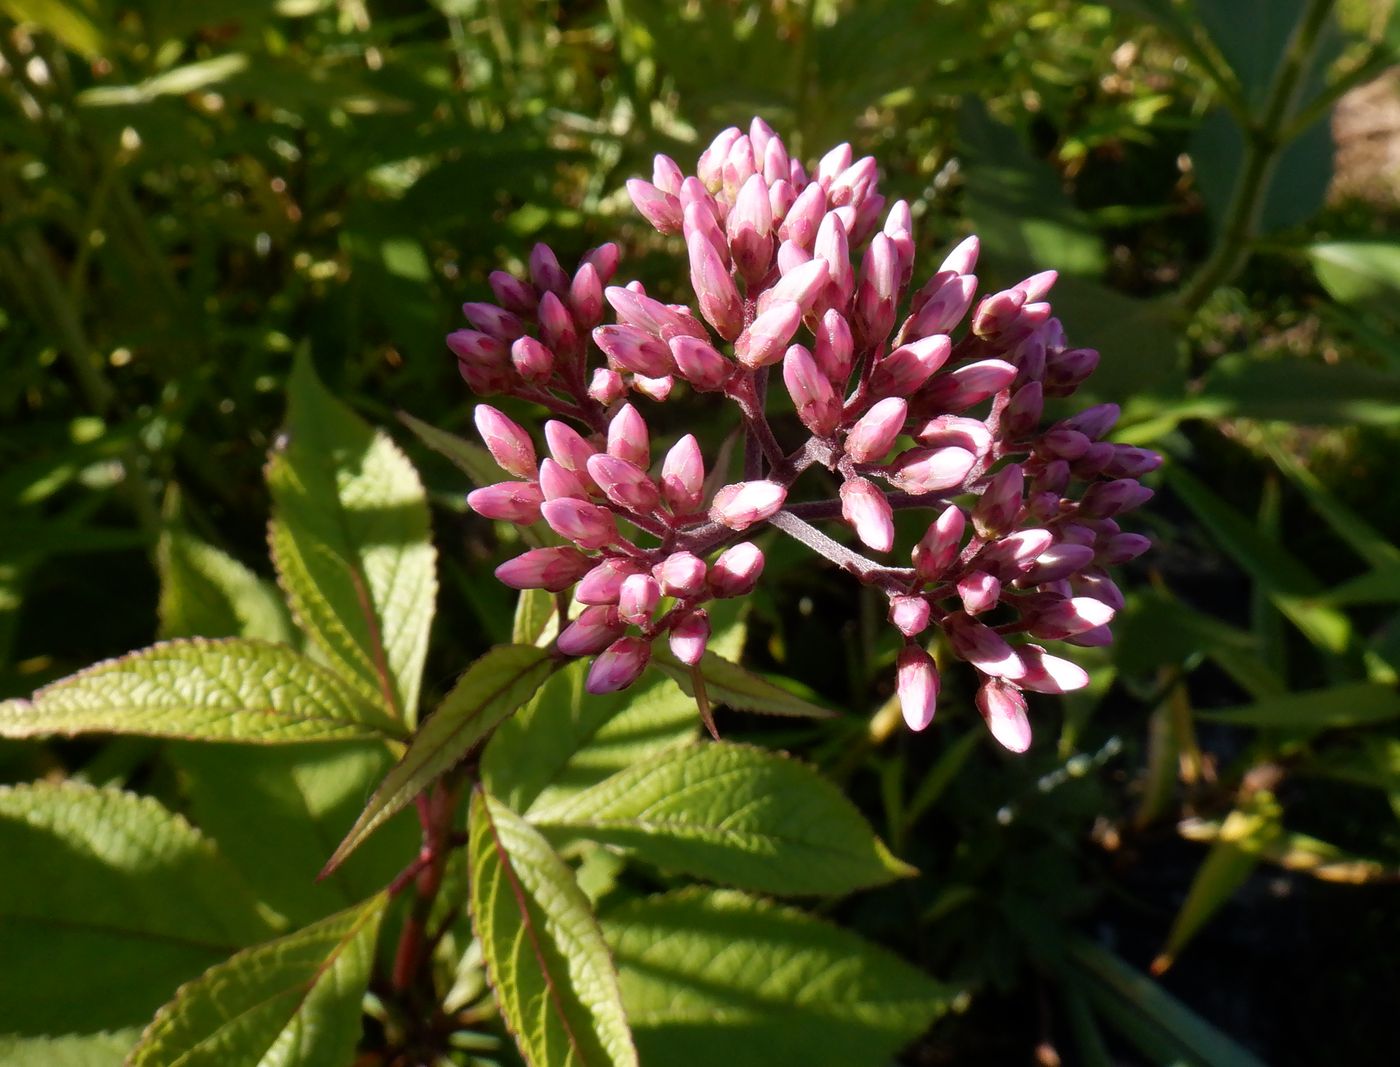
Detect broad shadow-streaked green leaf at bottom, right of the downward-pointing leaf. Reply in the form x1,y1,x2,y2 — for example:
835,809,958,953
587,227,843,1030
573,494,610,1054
603,889,956,1067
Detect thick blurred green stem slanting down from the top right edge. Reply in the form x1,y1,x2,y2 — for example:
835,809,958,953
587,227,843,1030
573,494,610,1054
1177,0,1334,315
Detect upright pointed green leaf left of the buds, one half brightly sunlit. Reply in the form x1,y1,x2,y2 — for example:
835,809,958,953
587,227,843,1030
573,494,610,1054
267,356,437,725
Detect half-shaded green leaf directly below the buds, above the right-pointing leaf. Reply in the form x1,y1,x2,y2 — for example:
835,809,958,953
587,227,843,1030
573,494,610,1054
482,660,699,812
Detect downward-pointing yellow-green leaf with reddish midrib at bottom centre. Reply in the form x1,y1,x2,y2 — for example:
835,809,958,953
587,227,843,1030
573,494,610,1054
468,790,637,1067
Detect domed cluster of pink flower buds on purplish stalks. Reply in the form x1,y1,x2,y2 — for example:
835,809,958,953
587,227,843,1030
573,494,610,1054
448,119,1159,752
